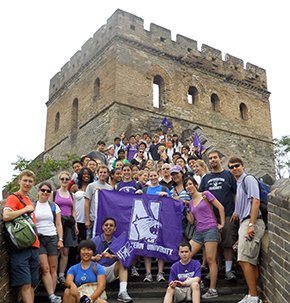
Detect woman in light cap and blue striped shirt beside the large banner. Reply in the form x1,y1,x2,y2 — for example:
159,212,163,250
170,165,193,240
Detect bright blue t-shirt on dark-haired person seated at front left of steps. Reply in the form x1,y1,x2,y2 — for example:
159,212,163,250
67,262,106,287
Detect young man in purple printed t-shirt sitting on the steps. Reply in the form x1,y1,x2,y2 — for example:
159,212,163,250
163,241,201,303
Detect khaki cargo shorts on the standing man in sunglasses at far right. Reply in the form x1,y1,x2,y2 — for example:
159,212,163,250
238,219,265,266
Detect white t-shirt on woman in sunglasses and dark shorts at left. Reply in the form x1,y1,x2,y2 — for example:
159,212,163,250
34,201,60,236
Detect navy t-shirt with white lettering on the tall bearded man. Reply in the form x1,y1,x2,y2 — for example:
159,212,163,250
198,170,237,218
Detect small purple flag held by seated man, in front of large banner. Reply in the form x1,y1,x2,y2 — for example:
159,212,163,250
109,231,135,269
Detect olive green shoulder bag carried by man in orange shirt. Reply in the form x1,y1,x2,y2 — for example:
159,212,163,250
5,194,36,251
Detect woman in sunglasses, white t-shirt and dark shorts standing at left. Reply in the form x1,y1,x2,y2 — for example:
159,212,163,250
35,182,63,303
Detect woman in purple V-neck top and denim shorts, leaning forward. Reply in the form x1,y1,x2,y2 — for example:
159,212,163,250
184,177,225,299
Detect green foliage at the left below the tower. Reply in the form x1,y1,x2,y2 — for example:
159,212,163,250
3,154,78,194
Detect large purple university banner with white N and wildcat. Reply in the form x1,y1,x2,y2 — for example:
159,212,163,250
96,190,184,261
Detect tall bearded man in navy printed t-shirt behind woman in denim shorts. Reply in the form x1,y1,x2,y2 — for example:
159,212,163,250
199,150,238,280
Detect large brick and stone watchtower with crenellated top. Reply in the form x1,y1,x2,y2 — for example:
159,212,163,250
44,10,274,172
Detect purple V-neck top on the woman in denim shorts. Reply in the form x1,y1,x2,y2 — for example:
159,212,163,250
189,191,217,232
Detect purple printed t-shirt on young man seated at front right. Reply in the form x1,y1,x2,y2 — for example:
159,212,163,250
168,259,201,284
